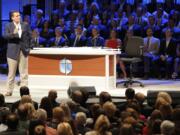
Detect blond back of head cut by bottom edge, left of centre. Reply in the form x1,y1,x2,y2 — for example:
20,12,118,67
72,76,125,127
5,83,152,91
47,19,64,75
57,122,73,135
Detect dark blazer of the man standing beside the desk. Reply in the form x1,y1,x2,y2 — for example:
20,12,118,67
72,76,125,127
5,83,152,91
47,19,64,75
4,22,32,60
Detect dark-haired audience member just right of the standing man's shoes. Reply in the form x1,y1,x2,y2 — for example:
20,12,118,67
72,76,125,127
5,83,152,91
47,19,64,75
11,86,38,112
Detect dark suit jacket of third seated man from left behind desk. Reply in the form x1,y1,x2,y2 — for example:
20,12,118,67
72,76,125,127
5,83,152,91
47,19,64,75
70,34,87,47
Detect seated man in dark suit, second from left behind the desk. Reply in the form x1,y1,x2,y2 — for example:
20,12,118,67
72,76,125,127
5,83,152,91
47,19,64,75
48,27,66,47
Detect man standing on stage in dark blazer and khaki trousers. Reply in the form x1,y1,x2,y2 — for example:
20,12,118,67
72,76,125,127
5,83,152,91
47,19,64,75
4,11,31,96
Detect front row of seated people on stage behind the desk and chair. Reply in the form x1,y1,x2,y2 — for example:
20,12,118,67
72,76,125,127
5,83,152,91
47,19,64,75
32,25,180,79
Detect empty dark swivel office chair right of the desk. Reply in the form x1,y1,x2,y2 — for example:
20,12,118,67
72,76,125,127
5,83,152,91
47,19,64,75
116,36,144,87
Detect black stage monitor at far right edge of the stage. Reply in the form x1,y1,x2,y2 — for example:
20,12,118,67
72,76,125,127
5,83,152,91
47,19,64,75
147,90,180,106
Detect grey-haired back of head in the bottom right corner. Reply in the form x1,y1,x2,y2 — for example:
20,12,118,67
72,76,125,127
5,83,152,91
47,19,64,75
161,120,175,135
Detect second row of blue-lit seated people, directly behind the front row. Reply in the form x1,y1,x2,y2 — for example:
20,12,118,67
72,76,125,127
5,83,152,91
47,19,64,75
30,8,180,40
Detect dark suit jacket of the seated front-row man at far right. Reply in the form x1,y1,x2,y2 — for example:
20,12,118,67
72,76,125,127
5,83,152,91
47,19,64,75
159,38,176,57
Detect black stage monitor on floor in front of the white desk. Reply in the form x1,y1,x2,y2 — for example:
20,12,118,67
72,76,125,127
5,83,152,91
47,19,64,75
67,86,96,97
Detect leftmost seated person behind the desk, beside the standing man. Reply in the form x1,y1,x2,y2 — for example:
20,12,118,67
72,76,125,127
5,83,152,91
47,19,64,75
31,28,47,47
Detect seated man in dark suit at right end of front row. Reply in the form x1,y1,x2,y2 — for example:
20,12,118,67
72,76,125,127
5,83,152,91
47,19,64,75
157,29,176,79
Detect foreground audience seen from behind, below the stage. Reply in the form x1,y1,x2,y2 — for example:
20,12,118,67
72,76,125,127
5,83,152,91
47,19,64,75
0,87,180,135
